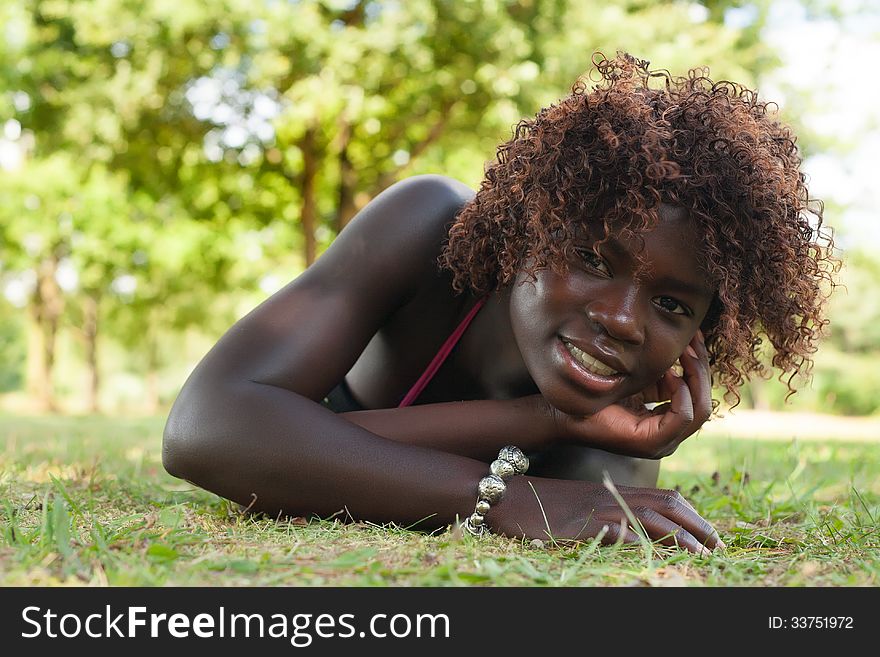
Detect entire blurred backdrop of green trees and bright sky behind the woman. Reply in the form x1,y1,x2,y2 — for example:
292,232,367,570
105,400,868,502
0,0,880,417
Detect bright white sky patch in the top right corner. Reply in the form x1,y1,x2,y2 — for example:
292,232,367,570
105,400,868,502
762,0,880,248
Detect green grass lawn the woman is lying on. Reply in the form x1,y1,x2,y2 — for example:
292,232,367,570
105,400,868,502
0,415,880,586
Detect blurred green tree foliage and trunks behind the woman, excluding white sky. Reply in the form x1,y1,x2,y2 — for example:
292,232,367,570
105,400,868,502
0,0,773,408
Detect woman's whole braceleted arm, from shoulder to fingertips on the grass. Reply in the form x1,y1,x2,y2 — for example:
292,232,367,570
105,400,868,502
163,177,714,550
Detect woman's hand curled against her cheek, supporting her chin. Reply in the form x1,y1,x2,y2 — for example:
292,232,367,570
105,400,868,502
553,331,712,459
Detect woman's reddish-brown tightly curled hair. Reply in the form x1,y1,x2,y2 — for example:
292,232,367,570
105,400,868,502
439,53,839,403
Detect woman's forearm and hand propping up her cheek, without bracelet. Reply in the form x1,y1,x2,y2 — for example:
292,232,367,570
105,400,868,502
341,332,712,460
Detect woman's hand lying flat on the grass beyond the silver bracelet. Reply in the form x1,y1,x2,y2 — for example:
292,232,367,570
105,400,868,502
486,477,725,555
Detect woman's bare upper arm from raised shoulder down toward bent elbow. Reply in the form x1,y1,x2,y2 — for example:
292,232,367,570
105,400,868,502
180,175,473,399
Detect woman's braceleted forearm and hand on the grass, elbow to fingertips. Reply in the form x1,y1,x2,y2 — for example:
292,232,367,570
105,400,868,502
163,374,719,552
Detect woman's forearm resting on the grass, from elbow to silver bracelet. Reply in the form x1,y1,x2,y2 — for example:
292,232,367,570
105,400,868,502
163,381,486,528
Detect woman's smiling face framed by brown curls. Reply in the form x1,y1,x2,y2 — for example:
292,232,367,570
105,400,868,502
510,205,714,415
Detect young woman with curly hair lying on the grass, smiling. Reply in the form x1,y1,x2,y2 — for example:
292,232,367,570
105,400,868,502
163,55,833,553
